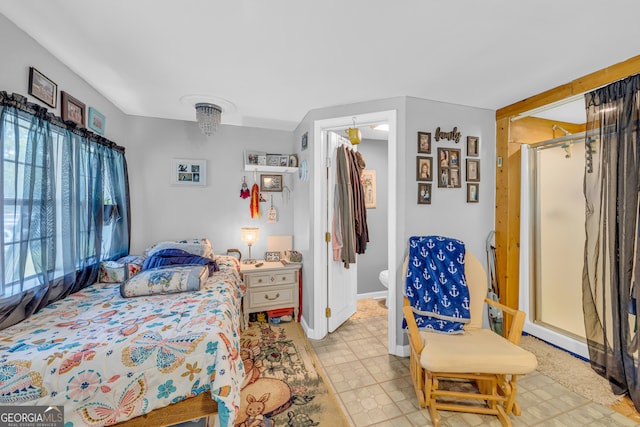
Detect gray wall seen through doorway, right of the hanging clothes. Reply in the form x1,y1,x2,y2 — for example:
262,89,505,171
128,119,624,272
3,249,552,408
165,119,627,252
356,139,388,295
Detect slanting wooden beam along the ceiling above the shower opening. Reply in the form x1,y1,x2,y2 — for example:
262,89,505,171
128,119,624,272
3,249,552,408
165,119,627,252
496,55,640,120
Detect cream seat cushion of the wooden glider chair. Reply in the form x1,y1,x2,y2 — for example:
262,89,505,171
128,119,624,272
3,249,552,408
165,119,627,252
420,328,538,374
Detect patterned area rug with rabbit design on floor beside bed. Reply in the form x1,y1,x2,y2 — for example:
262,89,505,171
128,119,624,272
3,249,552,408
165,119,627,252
236,322,349,427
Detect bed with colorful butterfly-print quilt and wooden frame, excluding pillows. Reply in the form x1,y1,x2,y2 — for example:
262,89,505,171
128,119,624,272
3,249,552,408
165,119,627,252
0,255,244,427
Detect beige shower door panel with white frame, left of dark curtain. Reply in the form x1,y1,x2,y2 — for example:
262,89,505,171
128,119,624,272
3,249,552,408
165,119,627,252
520,136,588,357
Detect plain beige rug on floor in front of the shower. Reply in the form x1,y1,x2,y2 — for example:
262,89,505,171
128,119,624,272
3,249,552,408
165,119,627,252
520,335,622,406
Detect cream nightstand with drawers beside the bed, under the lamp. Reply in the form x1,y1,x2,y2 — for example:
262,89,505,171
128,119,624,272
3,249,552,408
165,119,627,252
240,261,302,327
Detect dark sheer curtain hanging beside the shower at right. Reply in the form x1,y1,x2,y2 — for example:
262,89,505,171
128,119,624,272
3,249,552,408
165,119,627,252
582,75,640,410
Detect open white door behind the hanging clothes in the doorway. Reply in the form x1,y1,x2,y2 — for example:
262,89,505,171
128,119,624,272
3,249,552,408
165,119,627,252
325,132,358,332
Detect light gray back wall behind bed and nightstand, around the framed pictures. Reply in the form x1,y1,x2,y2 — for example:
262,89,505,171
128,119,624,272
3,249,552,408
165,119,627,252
127,117,298,258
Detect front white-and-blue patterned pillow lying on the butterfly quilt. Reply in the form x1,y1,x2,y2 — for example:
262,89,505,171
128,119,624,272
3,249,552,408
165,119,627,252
120,265,209,298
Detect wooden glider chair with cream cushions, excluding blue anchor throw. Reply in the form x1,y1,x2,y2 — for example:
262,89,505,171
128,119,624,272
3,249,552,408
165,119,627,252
403,246,537,427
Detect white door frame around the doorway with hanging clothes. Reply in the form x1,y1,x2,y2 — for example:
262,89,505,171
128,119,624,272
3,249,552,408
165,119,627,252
313,110,403,356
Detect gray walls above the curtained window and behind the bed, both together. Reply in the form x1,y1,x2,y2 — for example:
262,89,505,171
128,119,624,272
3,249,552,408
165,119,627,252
0,15,296,257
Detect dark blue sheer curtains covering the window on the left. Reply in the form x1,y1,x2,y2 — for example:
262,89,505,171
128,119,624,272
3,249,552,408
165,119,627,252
0,92,130,329
